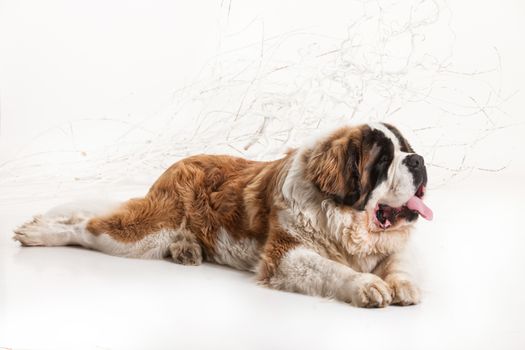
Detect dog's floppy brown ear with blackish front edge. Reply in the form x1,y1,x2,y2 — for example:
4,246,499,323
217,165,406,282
306,137,361,205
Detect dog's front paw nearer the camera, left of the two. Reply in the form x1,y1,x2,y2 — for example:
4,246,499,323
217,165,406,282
351,273,392,307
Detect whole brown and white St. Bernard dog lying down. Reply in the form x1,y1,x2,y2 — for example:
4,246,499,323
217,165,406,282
14,124,432,307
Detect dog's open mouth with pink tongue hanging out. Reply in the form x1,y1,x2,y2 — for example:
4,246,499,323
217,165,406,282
374,185,434,229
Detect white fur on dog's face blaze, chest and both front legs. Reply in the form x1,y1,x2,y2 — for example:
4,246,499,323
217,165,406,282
268,124,419,306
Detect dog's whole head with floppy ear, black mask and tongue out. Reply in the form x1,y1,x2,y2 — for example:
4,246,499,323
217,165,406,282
306,124,432,230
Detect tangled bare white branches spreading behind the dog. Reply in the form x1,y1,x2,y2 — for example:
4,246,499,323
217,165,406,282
0,0,512,202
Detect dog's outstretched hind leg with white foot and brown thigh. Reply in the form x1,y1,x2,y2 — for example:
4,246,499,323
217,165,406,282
14,197,189,259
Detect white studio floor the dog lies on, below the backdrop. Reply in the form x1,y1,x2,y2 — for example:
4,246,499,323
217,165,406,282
0,173,525,350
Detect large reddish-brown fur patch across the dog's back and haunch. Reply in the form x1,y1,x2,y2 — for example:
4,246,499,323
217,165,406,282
87,152,293,255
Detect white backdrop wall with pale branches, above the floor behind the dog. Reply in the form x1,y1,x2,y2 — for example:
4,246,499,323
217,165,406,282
0,0,525,200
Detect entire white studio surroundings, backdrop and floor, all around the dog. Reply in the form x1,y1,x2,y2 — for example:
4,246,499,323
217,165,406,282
0,0,525,349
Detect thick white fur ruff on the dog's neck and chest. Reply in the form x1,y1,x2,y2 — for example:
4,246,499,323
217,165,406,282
278,149,413,260
